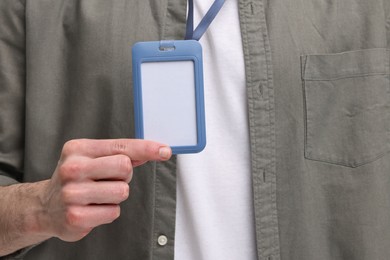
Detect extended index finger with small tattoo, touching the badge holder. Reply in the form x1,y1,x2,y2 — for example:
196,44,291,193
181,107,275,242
62,139,172,161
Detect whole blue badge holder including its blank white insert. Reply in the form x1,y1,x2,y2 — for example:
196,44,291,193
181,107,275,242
132,40,206,154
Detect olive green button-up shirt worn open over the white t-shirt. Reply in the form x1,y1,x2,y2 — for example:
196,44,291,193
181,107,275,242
0,0,390,260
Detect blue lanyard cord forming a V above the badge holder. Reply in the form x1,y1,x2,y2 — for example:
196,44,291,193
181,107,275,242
185,0,225,41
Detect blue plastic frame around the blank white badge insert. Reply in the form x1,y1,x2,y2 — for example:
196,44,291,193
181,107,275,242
132,40,206,154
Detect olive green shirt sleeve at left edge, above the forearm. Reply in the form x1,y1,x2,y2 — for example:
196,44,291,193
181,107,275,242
0,0,26,185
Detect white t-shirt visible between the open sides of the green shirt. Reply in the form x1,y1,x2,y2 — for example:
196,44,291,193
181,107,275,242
175,0,256,260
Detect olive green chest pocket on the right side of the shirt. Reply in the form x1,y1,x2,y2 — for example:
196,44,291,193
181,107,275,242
301,49,390,167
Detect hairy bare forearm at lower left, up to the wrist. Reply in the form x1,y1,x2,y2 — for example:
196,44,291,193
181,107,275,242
0,181,50,256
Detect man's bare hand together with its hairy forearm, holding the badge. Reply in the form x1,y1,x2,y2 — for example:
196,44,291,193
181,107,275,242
0,139,171,256
